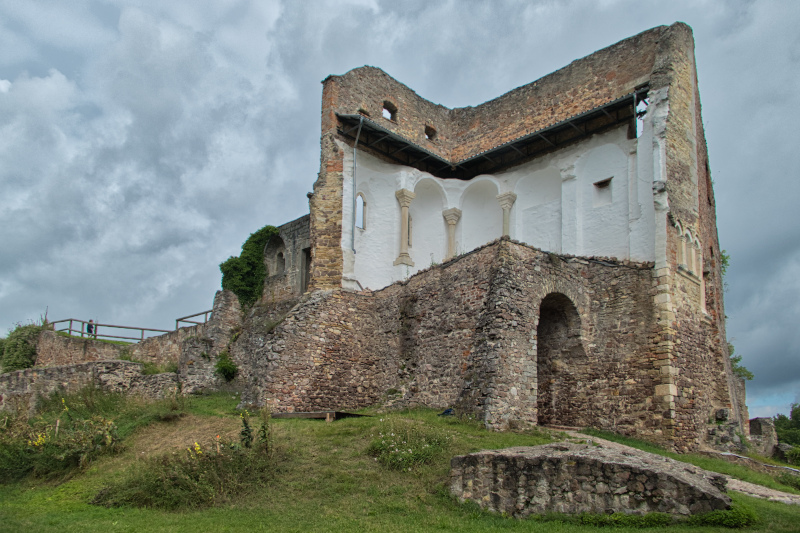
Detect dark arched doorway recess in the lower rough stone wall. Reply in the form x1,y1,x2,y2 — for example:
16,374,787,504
536,293,591,426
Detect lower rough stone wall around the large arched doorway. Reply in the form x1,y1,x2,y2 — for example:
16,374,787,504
232,240,696,445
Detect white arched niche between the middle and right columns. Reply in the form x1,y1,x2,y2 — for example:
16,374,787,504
456,179,503,253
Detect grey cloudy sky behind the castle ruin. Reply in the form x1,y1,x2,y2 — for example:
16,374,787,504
0,0,800,416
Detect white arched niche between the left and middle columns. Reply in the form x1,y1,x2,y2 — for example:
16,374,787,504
409,179,447,270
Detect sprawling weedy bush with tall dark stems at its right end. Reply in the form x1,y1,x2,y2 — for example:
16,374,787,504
92,411,273,510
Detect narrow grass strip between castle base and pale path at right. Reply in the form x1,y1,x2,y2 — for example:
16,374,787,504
583,429,800,494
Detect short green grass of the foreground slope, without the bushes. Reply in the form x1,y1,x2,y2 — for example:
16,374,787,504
0,396,800,533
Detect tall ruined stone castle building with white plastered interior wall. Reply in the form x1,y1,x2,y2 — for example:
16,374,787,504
247,23,746,450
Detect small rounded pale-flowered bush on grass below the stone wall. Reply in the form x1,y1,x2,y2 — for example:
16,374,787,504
367,418,451,471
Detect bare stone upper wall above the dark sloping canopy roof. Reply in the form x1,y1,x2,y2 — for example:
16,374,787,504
322,22,691,162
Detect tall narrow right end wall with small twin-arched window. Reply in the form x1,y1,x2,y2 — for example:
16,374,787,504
651,25,746,451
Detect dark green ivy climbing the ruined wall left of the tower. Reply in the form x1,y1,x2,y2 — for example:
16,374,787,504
219,226,278,307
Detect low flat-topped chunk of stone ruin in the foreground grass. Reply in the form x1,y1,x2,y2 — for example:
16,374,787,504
450,442,731,518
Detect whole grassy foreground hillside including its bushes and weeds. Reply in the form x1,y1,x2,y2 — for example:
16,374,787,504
0,391,800,533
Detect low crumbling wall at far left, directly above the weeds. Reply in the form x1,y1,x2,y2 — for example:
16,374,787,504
0,361,179,412
